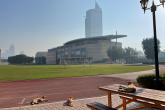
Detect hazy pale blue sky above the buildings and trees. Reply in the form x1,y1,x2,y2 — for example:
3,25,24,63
0,0,165,56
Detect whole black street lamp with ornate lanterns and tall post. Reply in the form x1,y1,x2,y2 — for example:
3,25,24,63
140,0,165,89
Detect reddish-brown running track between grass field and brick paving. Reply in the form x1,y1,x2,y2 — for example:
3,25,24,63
0,76,128,108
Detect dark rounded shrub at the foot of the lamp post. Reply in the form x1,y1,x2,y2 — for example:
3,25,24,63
137,74,165,90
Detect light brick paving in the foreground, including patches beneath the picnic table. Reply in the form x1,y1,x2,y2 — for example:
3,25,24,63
0,95,155,110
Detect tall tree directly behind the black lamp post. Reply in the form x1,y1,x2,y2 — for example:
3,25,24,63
142,38,160,60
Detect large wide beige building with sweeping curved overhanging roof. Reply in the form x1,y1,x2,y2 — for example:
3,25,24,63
46,35,126,64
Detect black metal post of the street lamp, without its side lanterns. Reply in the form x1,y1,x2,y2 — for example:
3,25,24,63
151,2,160,87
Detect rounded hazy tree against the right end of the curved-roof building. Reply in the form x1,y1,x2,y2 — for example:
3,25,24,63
107,46,123,62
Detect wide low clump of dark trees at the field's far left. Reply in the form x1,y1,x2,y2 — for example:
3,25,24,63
8,54,34,64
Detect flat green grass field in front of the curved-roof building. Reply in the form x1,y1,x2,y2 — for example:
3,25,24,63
0,64,153,81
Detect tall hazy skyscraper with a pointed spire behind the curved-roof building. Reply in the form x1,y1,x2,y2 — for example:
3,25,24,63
85,2,103,38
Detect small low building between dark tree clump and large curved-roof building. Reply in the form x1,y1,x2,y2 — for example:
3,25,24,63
35,52,47,65
